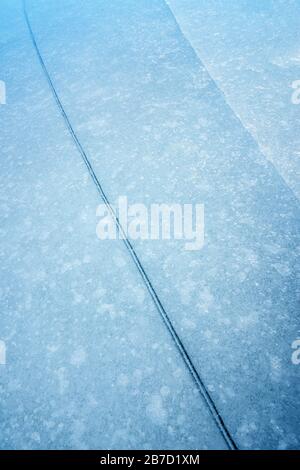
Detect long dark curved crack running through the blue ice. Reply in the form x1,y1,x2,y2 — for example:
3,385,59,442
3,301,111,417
23,0,238,450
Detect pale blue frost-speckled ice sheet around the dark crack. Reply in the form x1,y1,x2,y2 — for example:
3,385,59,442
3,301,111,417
0,0,300,449
